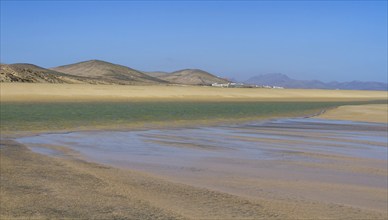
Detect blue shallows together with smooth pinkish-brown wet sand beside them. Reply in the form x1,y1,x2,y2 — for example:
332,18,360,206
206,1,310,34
17,118,388,210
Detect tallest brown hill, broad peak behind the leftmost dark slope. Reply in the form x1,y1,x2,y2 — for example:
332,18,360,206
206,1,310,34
52,60,166,84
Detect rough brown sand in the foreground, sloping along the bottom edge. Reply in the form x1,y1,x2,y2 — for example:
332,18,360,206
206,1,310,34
0,140,386,219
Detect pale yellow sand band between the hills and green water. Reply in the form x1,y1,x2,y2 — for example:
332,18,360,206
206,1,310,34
0,83,388,102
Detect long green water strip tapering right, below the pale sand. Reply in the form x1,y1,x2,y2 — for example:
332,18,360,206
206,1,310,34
0,101,380,133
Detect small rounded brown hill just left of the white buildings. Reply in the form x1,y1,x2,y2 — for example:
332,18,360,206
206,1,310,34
159,69,229,85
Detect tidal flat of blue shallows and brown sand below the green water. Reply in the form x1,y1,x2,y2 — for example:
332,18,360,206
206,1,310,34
0,118,388,219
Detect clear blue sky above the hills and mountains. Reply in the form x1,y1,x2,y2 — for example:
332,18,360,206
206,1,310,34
0,1,387,82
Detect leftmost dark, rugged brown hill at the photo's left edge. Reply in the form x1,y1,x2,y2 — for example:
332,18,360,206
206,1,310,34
0,63,98,83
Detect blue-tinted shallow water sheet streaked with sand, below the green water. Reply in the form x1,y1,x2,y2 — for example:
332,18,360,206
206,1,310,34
17,118,388,162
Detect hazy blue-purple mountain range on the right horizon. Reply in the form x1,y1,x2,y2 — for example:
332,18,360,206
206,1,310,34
244,73,388,90
